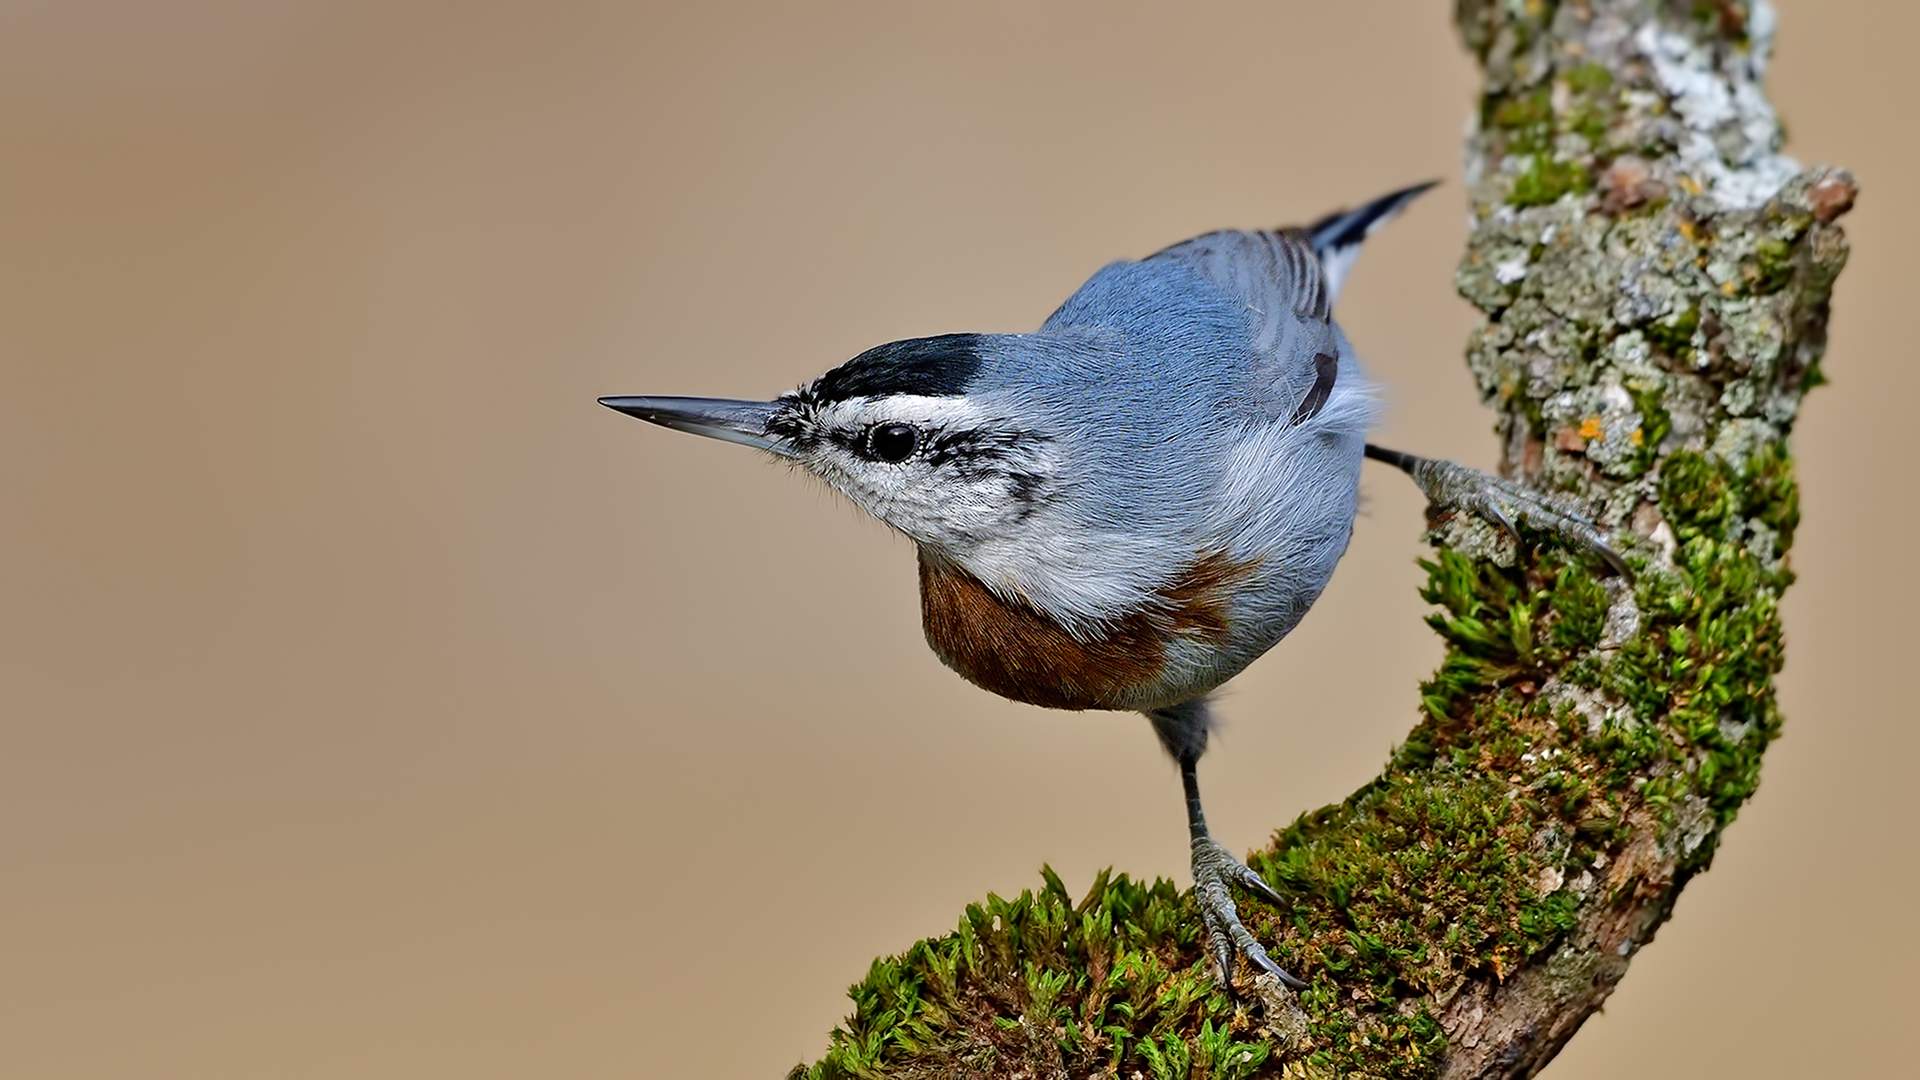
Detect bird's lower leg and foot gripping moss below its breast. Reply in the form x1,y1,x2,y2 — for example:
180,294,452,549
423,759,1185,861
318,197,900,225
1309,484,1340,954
1146,698,1306,990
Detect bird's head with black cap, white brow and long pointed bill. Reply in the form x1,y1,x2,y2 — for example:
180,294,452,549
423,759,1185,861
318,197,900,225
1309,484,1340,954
601,334,1058,559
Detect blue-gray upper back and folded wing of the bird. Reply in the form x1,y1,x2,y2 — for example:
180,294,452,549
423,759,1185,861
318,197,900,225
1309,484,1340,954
952,233,1365,532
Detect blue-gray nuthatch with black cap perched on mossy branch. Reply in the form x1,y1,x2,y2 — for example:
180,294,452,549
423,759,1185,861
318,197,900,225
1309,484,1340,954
599,181,1628,990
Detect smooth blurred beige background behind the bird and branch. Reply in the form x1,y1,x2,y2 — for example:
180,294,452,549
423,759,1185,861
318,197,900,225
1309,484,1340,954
0,0,1920,1080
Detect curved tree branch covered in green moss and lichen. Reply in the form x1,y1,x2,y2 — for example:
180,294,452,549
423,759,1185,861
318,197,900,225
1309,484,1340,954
793,0,1855,1078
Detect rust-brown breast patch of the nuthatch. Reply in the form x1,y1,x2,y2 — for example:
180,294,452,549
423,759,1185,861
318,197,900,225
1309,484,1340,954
920,552,1258,709
